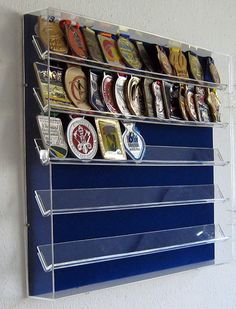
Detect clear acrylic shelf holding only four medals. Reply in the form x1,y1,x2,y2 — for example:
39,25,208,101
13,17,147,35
34,138,229,166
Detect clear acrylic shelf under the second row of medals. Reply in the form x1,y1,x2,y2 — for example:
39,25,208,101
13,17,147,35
33,88,228,128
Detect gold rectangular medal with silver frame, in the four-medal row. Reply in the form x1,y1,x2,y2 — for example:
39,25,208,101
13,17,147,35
95,118,126,160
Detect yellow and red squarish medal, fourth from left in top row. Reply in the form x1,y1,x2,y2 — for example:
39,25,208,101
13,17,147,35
98,34,124,66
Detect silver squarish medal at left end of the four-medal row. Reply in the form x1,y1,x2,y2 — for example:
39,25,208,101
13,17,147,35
37,115,68,159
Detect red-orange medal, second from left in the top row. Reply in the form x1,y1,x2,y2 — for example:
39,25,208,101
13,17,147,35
66,25,88,58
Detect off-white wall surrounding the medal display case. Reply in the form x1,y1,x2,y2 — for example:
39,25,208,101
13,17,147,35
0,0,236,309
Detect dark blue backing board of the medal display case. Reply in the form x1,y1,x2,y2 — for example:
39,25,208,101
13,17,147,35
24,15,214,295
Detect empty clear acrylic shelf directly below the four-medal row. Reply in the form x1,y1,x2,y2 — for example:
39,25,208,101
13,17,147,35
35,185,227,216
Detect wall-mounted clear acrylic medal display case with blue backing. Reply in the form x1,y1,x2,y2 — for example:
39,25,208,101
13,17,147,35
24,8,234,299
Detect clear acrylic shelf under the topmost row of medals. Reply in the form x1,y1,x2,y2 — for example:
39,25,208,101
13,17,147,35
32,35,228,90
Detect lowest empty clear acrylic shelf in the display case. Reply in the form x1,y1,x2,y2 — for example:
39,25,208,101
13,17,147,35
37,224,229,272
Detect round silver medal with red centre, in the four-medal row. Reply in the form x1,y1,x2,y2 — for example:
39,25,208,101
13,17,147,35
67,118,98,159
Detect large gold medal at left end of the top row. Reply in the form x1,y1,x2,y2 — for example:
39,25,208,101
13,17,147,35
38,17,68,54
